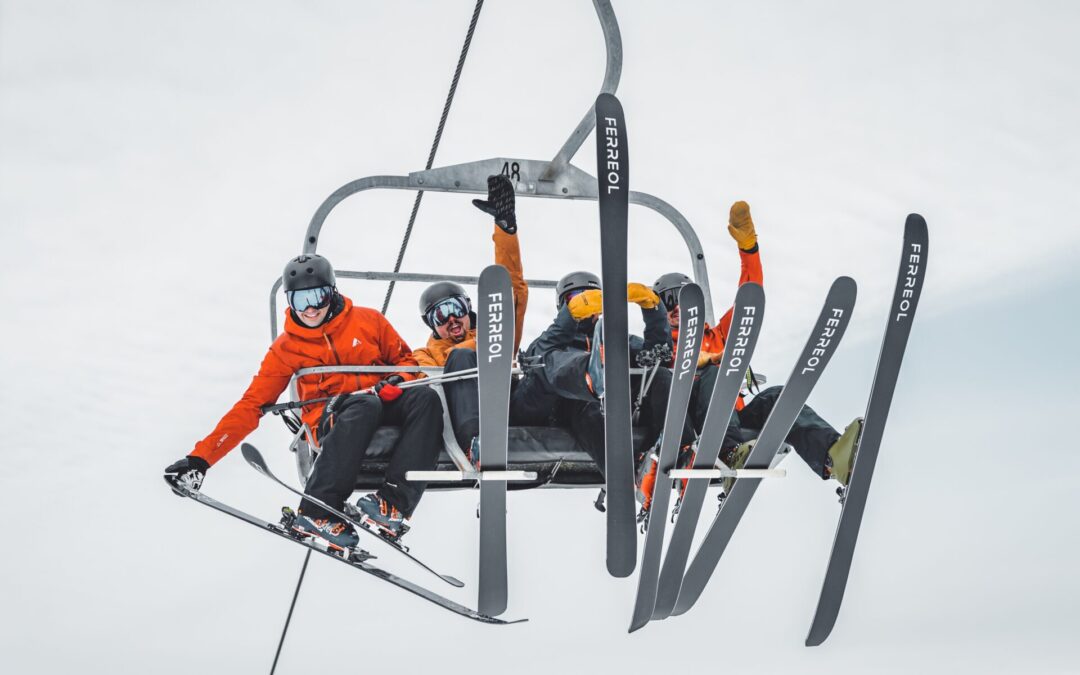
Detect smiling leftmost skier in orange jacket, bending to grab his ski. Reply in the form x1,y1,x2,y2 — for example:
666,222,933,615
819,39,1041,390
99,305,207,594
165,255,443,549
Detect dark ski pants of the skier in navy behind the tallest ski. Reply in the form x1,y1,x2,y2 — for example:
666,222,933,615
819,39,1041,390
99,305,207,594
510,350,693,473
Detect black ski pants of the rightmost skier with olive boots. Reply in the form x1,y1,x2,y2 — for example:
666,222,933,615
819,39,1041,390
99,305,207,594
721,387,840,478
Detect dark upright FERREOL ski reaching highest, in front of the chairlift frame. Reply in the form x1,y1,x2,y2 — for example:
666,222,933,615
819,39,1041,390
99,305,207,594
594,89,637,577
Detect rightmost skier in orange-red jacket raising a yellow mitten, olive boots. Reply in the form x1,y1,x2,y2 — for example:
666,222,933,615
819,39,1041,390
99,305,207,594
652,201,862,489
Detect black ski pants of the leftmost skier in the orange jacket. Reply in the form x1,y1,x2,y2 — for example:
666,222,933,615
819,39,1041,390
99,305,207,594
300,387,443,518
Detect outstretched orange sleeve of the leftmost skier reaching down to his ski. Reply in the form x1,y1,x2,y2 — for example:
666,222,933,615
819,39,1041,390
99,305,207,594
191,348,293,465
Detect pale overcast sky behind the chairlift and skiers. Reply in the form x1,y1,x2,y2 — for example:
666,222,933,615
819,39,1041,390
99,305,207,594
0,0,1080,673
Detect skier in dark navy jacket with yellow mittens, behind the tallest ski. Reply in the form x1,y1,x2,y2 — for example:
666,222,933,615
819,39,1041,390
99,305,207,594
510,266,693,494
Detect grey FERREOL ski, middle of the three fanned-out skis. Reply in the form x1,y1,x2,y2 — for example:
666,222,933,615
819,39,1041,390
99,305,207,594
652,283,765,619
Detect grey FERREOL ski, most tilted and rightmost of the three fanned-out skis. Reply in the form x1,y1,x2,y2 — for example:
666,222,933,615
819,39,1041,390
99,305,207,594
672,276,856,615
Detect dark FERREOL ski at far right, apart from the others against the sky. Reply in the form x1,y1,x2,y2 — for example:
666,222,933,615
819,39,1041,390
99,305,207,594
806,214,929,647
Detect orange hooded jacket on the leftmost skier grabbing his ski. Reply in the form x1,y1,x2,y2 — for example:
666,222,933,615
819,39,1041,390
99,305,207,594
191,297,417,464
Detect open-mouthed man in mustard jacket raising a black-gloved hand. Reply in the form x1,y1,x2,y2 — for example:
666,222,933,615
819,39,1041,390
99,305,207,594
413,174,529,461
